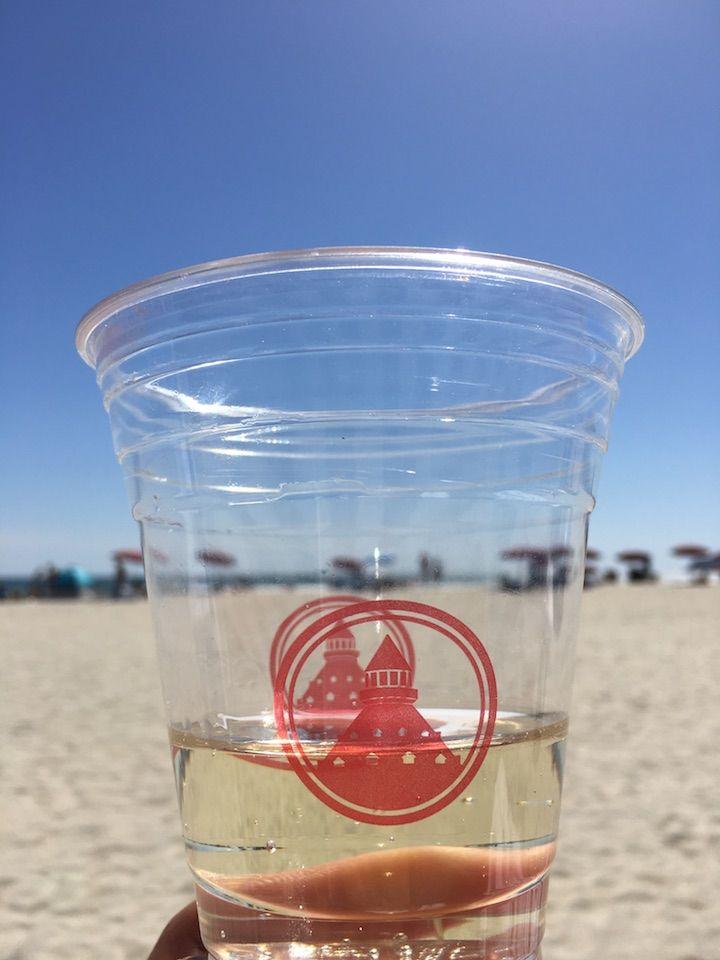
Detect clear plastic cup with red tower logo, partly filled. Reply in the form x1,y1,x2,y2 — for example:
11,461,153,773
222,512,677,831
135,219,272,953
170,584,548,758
77,248,642,960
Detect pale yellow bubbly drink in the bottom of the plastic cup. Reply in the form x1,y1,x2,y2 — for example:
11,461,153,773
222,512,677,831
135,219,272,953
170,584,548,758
170,711,567,960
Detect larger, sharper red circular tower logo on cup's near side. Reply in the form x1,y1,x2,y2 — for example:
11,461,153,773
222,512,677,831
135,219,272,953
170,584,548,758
274,597,497,824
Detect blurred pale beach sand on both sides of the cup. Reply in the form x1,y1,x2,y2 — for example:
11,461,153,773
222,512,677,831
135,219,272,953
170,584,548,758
0,587,720,960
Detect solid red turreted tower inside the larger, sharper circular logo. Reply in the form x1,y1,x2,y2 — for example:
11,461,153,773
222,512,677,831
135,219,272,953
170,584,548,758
320,636,461,810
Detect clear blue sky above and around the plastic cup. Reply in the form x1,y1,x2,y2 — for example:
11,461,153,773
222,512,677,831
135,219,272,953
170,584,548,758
0,0,720,574
